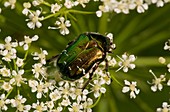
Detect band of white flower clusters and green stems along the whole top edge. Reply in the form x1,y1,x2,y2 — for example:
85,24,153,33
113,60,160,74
0,0,170,35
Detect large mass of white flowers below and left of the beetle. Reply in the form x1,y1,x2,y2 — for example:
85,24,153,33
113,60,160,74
0,35,115,112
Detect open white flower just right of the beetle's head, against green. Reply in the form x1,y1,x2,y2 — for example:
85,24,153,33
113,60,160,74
116,53,136,72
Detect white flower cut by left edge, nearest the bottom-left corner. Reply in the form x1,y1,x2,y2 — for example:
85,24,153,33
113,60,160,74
0,94,10,111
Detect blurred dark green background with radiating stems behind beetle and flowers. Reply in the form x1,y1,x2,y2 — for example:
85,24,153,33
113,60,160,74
0,3,170,112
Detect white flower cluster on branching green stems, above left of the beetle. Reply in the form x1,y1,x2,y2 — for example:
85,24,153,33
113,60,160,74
22,0,90,35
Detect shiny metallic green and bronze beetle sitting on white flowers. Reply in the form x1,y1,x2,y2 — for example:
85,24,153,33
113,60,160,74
49,32,113,89
